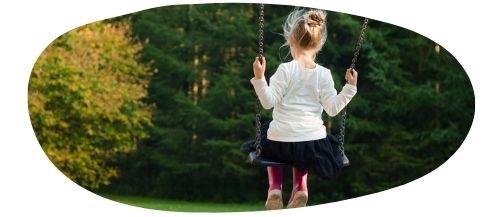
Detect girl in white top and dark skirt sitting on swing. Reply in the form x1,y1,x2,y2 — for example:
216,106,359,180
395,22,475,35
250,9,358,209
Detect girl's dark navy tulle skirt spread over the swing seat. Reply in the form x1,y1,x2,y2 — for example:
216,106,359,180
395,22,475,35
241,121,343,179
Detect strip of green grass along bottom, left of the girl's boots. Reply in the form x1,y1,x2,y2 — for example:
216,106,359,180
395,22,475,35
100,194,265,212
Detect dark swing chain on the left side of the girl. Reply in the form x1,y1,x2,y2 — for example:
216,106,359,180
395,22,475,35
254,4,265,157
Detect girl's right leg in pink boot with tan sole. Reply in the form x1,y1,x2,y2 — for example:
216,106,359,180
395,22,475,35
287,168,308,208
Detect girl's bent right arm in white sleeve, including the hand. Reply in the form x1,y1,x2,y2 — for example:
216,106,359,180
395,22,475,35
320,71,357,117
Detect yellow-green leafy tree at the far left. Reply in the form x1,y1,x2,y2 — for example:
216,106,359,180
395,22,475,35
29,20,155,189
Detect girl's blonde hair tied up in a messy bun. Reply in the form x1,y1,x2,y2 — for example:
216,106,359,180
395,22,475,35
283,8,327,51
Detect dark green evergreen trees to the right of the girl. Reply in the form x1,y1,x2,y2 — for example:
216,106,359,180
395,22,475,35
317,14,474,201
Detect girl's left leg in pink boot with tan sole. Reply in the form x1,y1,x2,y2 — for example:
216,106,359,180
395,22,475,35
265,167,284,209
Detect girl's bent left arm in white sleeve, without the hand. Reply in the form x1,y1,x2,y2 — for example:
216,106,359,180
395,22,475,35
251,65,289,109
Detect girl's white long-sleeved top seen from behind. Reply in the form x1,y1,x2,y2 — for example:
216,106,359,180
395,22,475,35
250,60,357,142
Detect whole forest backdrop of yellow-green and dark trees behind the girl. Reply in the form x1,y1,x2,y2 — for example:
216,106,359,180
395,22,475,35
29,4,474,204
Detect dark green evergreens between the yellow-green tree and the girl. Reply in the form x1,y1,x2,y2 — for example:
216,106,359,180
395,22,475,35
110,4,262,200
